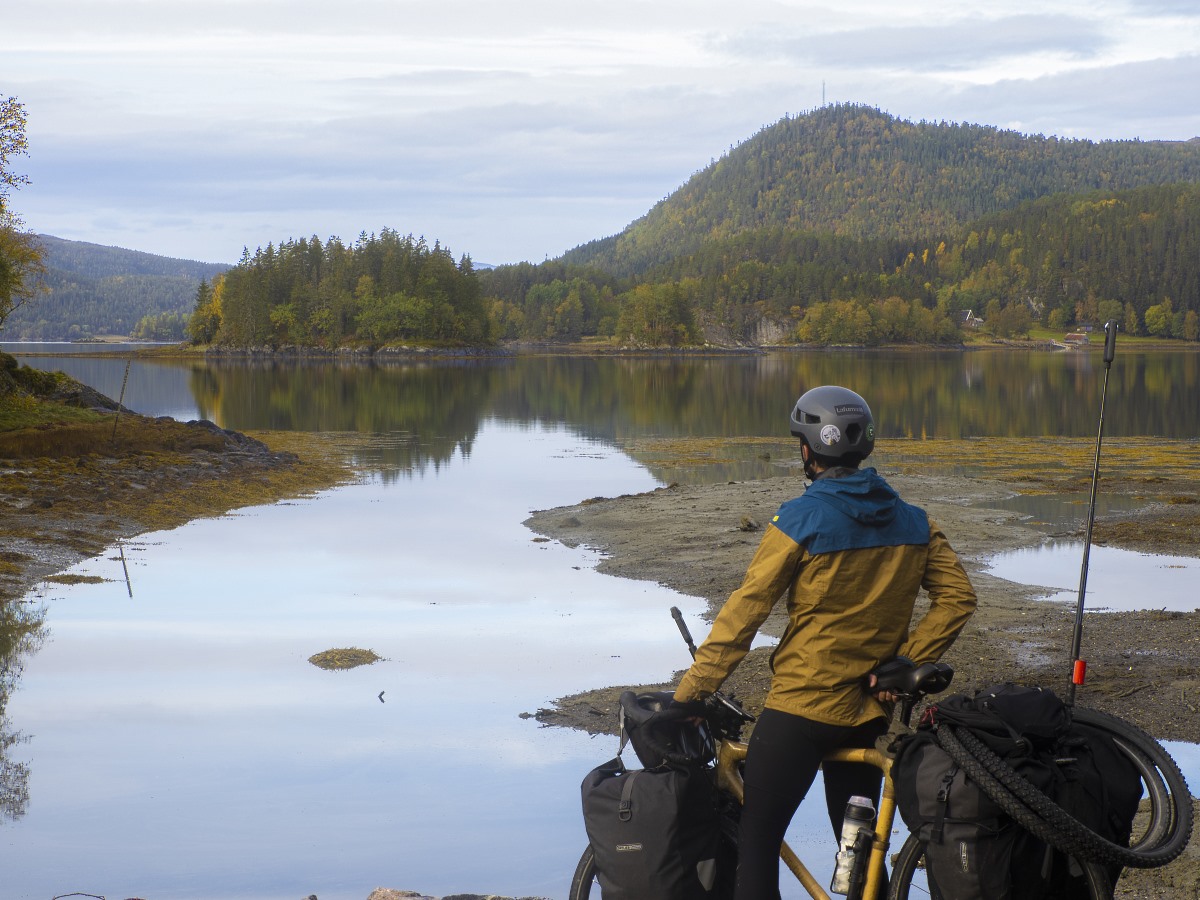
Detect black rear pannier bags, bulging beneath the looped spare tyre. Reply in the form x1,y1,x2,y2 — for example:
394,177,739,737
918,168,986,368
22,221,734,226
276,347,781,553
892,684,1141,900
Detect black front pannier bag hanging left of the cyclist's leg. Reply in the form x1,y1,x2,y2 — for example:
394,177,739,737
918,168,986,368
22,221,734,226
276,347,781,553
581,691,720,900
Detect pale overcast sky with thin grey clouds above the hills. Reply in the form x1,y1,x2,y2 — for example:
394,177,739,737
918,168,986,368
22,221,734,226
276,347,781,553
0,0,1200,263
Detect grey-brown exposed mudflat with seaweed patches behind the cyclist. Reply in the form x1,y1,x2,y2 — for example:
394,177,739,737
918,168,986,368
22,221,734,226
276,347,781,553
526,469,1200,743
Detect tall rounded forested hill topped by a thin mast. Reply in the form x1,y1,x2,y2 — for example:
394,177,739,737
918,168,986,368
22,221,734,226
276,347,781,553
562,106,1200,276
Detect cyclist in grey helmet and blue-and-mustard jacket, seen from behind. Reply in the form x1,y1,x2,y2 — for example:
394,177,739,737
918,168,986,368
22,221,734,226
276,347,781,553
674,385,976,900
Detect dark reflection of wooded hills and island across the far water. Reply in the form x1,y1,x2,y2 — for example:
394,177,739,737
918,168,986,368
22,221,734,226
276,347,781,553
9,350,1200,466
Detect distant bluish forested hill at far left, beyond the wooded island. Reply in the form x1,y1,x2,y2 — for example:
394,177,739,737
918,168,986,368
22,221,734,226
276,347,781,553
0,234,229,341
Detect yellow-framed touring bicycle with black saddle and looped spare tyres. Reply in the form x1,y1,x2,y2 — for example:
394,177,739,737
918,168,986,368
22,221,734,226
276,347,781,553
569,617,1192,900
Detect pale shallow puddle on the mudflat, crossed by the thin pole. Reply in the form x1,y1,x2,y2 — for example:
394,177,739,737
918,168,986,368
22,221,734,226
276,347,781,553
988,541,1200,612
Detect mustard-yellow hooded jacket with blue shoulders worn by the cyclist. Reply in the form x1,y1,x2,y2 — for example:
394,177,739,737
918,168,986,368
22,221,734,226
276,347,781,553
674,469,976,725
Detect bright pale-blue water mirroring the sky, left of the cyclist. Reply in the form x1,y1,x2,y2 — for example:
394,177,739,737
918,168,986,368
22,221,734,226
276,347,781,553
0,420,703,900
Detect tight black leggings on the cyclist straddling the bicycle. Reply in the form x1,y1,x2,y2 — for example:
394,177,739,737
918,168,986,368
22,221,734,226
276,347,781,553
734,709,888,900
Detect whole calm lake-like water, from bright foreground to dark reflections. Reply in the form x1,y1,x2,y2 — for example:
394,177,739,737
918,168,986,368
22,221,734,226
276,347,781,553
0,353,1200,900
